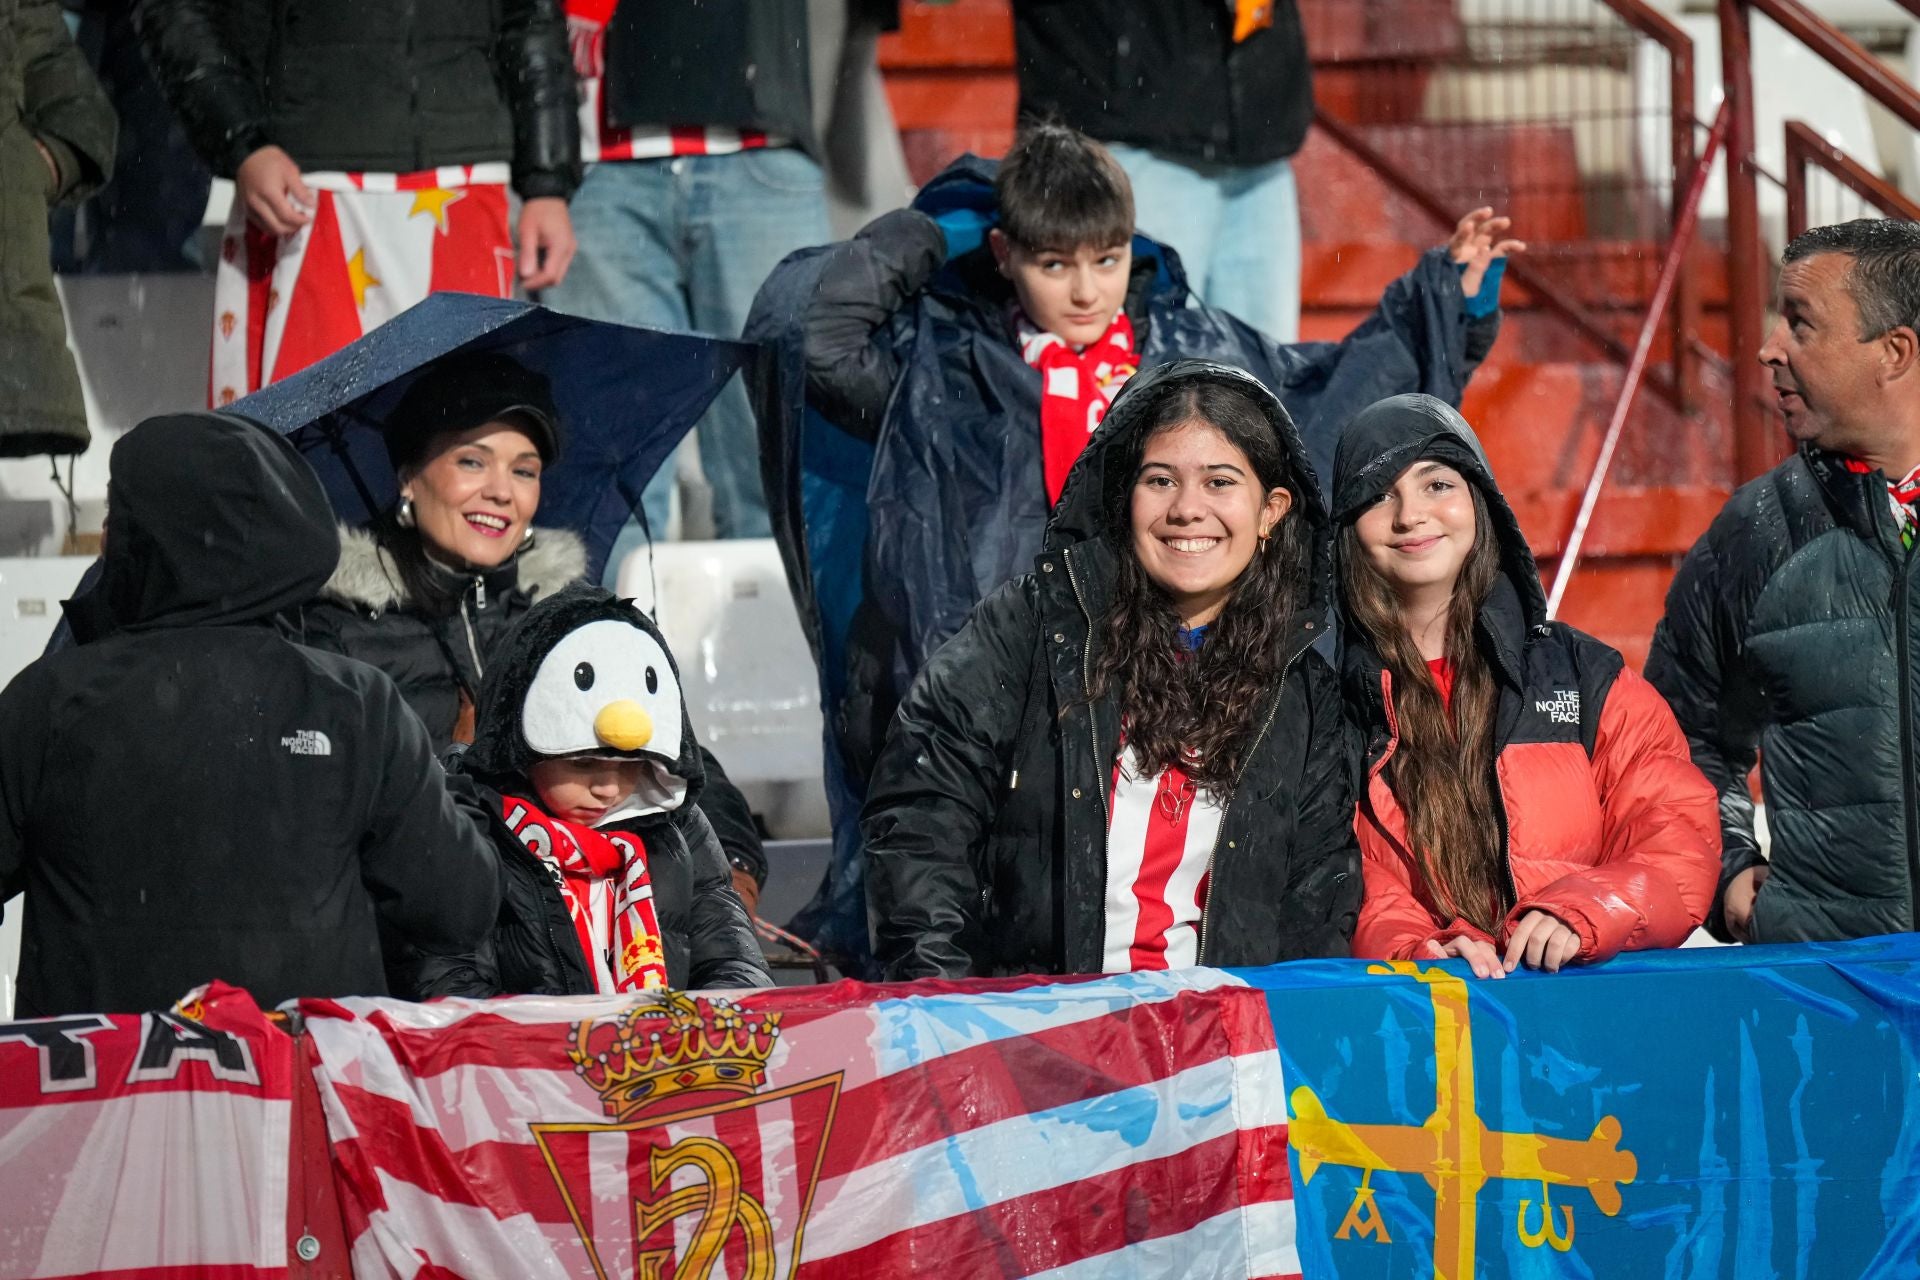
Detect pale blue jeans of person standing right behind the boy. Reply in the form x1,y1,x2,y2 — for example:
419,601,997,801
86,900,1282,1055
1108,142,1300,342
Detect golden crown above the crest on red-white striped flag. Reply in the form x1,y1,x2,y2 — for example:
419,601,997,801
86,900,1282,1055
566,992,780,1121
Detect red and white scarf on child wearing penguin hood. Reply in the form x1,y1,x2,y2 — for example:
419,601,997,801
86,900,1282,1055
501,796,666,996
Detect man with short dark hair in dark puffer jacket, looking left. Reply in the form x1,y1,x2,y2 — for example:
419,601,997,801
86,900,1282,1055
1647,219,1920,942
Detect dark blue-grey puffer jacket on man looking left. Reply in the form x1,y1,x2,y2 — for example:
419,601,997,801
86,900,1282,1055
1647,447,1920,942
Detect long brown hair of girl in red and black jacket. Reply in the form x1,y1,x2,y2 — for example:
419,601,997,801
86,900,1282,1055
1340,480,1511,933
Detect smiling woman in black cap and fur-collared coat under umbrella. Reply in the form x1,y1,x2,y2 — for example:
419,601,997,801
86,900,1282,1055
284,353,586,750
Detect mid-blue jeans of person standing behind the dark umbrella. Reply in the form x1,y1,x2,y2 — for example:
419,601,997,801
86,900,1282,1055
540,148,829,585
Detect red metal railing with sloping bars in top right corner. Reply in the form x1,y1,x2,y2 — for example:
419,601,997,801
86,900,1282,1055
1718,0,1920,480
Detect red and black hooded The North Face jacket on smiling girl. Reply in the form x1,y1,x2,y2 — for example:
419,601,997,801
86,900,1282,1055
1334,397,1718,961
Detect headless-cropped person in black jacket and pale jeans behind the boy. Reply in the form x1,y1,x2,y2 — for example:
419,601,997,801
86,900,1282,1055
1014,0,1313,342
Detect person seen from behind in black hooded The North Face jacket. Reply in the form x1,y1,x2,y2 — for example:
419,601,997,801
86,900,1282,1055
0,413,499,1017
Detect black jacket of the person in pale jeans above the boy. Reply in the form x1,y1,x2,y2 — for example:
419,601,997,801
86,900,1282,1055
1014,0,1313,165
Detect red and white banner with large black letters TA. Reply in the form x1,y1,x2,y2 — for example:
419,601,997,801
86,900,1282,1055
0,983,294,1280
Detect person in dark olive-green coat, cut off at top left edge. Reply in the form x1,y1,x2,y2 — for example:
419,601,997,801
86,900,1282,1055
0,0,115,457
